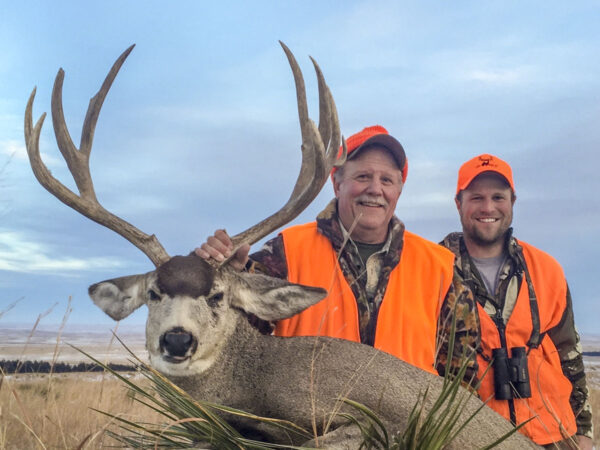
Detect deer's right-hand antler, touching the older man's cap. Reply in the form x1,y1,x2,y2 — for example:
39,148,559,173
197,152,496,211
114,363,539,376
223,41,346,266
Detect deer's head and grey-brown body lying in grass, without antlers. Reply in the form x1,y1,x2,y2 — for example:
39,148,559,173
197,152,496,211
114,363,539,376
90,254,535,449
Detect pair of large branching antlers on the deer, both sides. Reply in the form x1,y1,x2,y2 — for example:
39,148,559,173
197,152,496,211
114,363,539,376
25,42,346,267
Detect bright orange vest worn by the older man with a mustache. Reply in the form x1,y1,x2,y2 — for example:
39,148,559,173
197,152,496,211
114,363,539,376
275,222,454,373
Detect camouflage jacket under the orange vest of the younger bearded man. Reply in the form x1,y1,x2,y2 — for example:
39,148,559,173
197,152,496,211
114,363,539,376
441,228,593,438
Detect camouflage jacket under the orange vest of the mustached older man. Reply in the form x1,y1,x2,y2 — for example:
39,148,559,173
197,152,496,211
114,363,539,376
248,199,479,383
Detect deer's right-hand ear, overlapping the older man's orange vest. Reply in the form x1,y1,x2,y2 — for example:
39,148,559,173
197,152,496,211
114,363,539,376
232,273,327,321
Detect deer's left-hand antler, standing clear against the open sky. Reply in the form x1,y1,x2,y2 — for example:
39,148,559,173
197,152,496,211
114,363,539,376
25,45,169,267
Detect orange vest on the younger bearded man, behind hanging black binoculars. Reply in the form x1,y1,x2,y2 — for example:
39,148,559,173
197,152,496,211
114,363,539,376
477,241,577,445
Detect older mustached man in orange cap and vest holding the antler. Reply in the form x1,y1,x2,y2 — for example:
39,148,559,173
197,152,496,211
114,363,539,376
196,126,478,378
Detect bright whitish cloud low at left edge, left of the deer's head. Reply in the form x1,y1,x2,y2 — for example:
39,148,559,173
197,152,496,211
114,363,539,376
0,230,124,276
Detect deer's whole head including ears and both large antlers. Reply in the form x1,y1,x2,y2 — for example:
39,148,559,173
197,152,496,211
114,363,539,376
25,43,346,375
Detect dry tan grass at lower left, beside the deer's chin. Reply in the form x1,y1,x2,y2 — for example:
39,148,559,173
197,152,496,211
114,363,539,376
0,373,161,450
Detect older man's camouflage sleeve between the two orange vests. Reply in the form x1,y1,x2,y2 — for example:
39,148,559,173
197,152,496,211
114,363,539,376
436,268,480,386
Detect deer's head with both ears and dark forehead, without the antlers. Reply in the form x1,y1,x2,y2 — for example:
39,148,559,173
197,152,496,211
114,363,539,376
89,254,326,376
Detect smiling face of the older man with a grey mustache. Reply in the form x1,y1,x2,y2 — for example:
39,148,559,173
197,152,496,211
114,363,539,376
333,146,402,244
